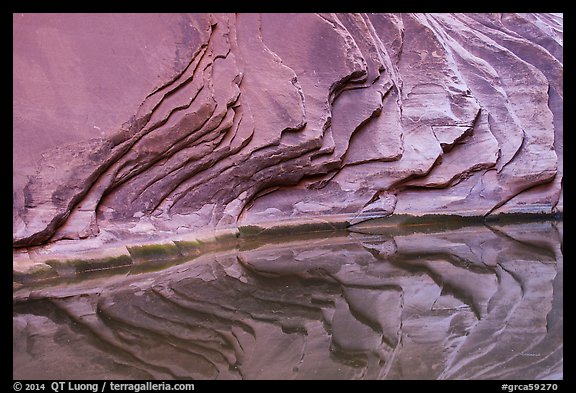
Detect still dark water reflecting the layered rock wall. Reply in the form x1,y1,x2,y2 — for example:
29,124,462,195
13,221,563,379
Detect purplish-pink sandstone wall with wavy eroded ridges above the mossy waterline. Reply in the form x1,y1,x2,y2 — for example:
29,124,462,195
13,14,563,247
